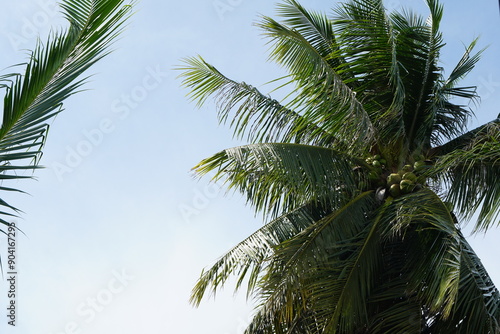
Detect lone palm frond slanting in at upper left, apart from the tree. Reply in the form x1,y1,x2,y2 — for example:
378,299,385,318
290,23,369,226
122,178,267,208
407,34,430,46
0,0,131,232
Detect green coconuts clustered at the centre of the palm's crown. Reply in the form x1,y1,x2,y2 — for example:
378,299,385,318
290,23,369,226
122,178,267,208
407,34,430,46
365,154,429,197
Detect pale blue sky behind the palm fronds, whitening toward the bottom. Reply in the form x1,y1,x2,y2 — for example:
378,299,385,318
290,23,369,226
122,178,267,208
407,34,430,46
0,0,500,334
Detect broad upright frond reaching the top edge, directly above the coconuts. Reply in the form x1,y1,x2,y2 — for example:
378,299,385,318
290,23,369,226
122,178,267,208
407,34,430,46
333,1,406,141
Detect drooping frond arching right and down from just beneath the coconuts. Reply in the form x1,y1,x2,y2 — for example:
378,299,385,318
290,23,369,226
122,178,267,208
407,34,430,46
383,189,460,317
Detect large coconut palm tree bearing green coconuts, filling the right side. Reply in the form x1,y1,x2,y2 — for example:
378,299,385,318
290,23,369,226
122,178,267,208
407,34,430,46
179,0,500,334
